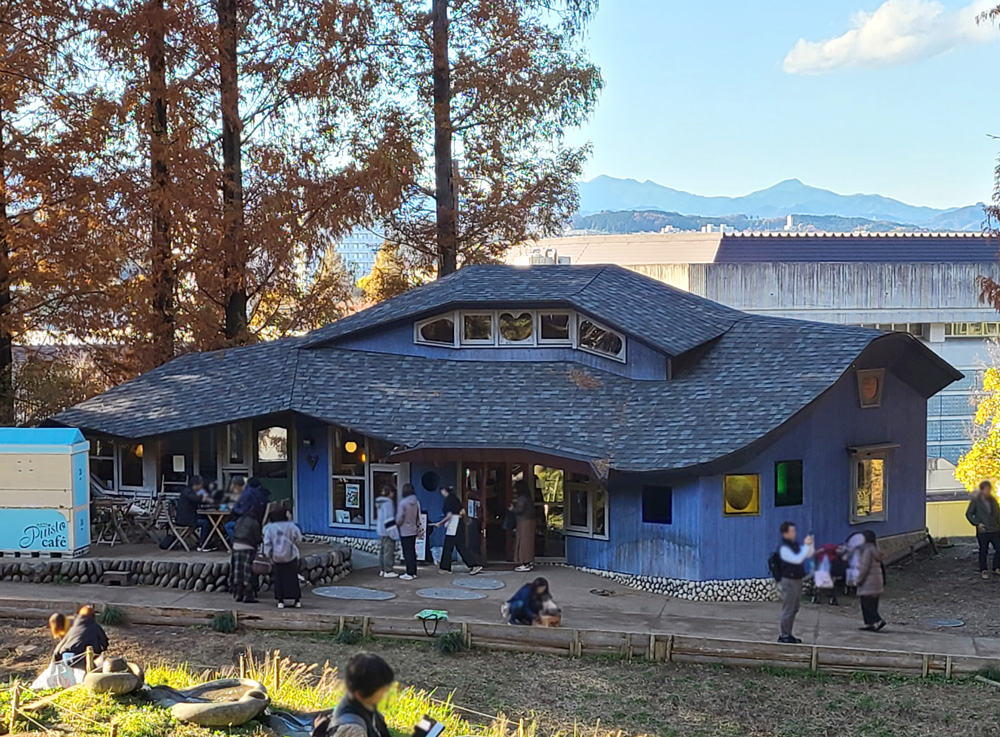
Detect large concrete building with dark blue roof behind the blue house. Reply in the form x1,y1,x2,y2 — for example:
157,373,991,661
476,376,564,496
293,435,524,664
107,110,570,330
511,232,1000,516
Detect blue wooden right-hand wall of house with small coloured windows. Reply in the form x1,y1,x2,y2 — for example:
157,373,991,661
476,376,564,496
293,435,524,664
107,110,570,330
566,372,927,581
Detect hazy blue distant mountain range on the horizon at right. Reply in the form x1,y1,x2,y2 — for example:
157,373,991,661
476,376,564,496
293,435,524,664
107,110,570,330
579,176,984,231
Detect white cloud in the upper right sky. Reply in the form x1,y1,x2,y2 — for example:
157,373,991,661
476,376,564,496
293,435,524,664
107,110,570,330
783,0,1000,74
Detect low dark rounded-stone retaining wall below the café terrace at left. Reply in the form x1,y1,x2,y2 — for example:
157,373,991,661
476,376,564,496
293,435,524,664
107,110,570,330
0,547,351,592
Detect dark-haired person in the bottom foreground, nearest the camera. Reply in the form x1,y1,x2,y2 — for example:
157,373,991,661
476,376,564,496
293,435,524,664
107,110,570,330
312,653,396,737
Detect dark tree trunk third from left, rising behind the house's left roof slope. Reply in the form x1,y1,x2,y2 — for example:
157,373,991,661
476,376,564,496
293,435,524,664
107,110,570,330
217,0,248,345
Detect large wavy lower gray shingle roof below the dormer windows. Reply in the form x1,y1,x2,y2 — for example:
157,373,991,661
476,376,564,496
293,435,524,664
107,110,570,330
55,304,957,471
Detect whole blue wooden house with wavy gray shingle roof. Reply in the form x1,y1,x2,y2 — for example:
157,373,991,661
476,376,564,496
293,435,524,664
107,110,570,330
55,266,961,600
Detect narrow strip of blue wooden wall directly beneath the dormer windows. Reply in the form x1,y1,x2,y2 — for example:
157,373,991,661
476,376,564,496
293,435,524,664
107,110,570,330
337,324,667,380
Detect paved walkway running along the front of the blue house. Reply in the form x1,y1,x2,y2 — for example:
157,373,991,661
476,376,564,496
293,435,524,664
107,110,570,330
0,553,1000,660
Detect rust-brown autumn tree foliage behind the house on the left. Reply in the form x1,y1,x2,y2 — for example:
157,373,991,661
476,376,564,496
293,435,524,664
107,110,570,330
0,0,600,424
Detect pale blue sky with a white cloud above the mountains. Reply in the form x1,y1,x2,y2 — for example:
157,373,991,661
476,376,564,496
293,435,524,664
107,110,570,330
572,0,1000,207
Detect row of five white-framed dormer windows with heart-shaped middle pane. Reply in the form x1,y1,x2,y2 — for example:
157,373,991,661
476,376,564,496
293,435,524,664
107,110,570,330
413,309,625,363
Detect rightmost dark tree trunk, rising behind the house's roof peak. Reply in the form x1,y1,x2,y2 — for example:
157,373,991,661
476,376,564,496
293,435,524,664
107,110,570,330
431,0,458,277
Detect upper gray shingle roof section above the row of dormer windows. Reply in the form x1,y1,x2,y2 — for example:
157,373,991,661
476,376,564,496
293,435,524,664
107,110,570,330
306,266,743,356
